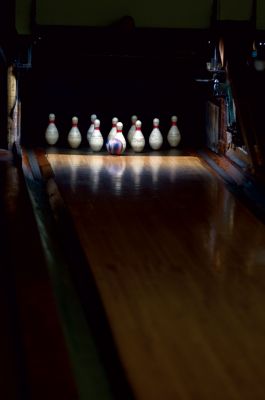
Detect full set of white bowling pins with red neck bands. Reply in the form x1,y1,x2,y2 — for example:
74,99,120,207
45,114,181,153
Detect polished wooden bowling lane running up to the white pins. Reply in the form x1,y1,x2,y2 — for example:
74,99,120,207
47,152,265,400
